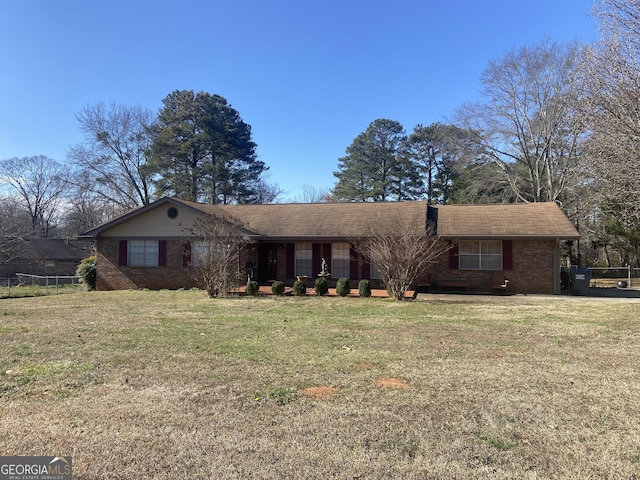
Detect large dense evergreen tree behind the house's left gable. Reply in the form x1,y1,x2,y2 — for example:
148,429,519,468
150,90,268,204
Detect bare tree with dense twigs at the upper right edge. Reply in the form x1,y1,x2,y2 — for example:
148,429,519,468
577,0,640,224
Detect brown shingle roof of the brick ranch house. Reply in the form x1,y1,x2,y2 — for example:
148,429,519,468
83,198,580,241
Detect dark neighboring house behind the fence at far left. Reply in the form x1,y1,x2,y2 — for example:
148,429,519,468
0,237,93,278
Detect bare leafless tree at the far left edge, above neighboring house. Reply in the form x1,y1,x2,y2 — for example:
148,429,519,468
0,155,69,237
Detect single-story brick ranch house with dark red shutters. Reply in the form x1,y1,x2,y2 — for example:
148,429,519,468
81,198,580,294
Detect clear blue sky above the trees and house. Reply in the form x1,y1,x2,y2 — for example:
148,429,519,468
0,0,597,201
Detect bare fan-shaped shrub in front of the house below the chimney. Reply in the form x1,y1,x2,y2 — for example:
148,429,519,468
351,221,451,300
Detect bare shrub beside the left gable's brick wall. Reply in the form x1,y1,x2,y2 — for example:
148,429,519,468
188,215,250,297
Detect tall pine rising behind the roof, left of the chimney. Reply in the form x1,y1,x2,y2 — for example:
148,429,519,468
332,119,418,202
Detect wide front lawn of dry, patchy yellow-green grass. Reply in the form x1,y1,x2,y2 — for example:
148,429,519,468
0,291,640,479
